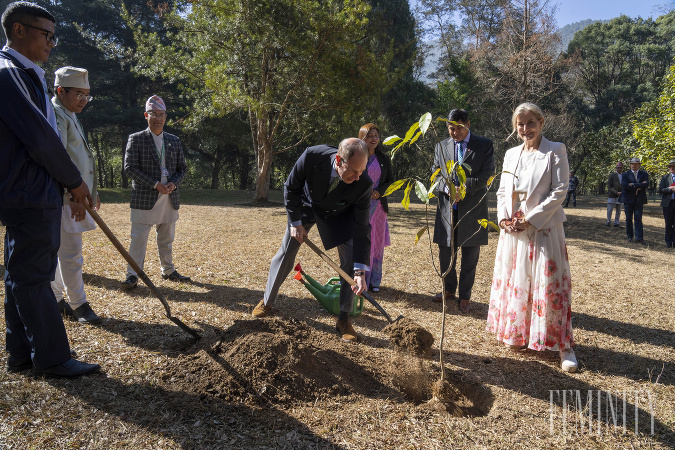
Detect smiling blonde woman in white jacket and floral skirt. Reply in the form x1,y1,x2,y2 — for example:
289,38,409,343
487,103,578,372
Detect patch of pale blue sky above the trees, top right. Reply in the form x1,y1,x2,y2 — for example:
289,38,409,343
551,0,673,27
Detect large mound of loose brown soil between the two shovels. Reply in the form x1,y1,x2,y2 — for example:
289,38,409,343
164,318,400,403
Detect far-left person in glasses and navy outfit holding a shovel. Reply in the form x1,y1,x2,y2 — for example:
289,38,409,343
0,2,100,377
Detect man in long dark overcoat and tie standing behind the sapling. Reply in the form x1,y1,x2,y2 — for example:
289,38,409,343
431,109,495,313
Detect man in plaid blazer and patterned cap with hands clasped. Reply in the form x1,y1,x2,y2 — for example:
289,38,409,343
122,95,190,289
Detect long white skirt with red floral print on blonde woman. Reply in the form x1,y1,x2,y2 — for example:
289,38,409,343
486,223,574,350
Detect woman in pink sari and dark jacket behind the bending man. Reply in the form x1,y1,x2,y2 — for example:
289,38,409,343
359,123,394,292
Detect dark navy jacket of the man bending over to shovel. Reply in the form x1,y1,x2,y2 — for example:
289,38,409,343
284,145,373,265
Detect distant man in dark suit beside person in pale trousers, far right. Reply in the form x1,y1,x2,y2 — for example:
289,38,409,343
621,158,649,245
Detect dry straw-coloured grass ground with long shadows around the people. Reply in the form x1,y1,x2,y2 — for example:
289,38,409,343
0,195,675,449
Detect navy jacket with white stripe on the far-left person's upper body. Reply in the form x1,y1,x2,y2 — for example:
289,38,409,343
0,51,82,223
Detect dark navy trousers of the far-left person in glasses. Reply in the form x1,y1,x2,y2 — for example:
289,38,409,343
5,221,70,369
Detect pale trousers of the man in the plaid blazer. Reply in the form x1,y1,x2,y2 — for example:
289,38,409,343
127,222,176,275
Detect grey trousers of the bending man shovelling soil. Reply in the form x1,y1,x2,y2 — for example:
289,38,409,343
264,224,354,312
